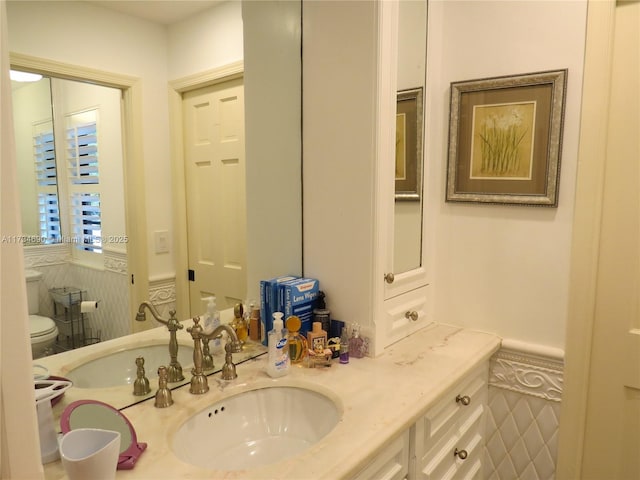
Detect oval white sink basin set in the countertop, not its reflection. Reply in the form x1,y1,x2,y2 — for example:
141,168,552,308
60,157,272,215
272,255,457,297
172,386,342,471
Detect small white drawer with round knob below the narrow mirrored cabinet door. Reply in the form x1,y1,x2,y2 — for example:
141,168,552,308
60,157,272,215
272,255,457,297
384,286,429,346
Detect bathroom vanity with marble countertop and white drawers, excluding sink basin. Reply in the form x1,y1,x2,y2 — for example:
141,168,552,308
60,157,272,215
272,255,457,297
40,324,500,480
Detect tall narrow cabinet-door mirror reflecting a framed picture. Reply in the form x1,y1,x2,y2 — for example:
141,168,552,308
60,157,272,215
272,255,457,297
393,0,427,274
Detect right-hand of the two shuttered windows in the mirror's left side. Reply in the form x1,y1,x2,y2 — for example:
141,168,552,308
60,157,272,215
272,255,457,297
66,110,102,253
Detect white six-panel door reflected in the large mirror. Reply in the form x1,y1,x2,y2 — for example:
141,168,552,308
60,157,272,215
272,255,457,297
183,79,247,312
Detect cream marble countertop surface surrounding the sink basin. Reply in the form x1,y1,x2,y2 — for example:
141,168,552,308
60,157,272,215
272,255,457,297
45,324,500,480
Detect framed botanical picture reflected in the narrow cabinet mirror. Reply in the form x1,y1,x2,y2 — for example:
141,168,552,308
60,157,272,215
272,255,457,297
395,87,423,201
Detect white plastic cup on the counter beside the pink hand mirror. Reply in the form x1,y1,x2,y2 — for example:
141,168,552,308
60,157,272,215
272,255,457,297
60,428,120,480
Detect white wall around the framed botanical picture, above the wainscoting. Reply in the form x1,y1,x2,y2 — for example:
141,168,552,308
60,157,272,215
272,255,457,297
425,0,587,348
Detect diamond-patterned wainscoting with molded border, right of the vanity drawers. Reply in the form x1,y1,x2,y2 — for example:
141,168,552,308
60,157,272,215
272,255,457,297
484,342,564,480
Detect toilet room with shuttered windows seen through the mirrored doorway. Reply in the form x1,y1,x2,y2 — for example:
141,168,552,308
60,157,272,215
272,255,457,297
12,70,129,353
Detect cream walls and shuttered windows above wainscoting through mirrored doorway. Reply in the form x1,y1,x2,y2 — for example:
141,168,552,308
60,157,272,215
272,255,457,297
12,77,126,251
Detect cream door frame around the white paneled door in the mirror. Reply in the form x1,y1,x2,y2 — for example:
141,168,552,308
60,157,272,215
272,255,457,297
169,60,246,318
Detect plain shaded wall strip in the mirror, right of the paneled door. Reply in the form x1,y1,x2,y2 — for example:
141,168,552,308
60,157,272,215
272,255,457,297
242,1,302,299
